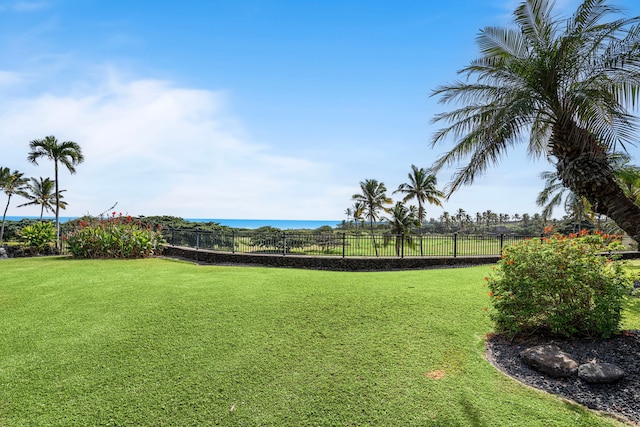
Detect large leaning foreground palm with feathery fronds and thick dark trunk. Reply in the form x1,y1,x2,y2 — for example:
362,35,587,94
432,0,640,241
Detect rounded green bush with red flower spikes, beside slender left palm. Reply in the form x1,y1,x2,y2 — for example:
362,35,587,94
64,212,165,258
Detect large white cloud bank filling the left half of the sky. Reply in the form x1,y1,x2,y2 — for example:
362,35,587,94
0,73,352,219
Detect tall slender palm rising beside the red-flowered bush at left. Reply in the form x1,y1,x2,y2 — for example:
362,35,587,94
27,135,84,249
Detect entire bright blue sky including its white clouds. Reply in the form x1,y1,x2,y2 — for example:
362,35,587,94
0,0,640,220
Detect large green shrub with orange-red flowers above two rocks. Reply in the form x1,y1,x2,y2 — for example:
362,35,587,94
486,229,633,338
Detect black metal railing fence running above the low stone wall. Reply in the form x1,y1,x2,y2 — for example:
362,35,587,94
163,229,530,258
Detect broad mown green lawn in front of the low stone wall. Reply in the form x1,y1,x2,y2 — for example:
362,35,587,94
0,258,632,426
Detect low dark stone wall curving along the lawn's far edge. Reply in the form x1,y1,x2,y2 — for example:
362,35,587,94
162,246,499,271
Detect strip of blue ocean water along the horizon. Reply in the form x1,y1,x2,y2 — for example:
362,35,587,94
7,216,342,230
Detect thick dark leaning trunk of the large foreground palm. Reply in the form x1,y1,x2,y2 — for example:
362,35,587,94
551,120,640,242
